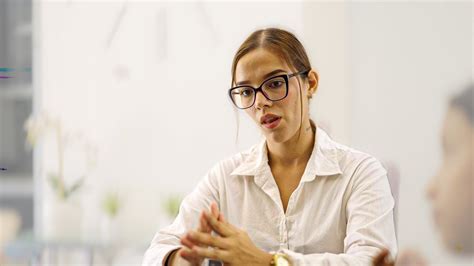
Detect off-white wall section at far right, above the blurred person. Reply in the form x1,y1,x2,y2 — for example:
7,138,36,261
348,2,473,265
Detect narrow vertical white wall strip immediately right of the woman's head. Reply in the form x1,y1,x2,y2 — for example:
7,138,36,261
301,1,352,144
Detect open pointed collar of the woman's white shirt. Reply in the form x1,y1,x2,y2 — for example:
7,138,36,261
231,120,342,181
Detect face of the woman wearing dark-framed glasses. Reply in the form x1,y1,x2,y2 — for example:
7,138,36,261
235,49,317,143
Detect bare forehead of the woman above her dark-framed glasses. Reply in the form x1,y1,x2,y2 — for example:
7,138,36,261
235,49,290,83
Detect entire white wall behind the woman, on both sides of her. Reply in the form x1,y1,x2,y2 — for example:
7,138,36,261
35,1,472,261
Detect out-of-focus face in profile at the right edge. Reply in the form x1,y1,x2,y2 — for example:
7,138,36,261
428,107,474,253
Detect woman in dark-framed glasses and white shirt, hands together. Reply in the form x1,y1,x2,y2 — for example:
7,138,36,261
143,28,397,265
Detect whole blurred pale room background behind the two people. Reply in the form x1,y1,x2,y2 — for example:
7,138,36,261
0,0,473,265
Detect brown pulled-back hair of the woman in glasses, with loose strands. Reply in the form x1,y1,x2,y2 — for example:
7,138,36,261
231,28,311,140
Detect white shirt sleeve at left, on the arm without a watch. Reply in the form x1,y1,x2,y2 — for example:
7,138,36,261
142,166,219,266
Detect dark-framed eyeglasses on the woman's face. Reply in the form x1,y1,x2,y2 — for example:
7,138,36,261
229,70,309,109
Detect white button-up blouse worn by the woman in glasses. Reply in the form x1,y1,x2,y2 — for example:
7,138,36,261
143,127,397,265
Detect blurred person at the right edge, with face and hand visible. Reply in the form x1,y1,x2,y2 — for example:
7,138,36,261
374,84,474,265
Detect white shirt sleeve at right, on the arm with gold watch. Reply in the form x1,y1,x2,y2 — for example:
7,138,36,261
281,158,397,266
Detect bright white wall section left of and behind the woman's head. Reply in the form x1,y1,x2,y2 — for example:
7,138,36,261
35,2,310,243
